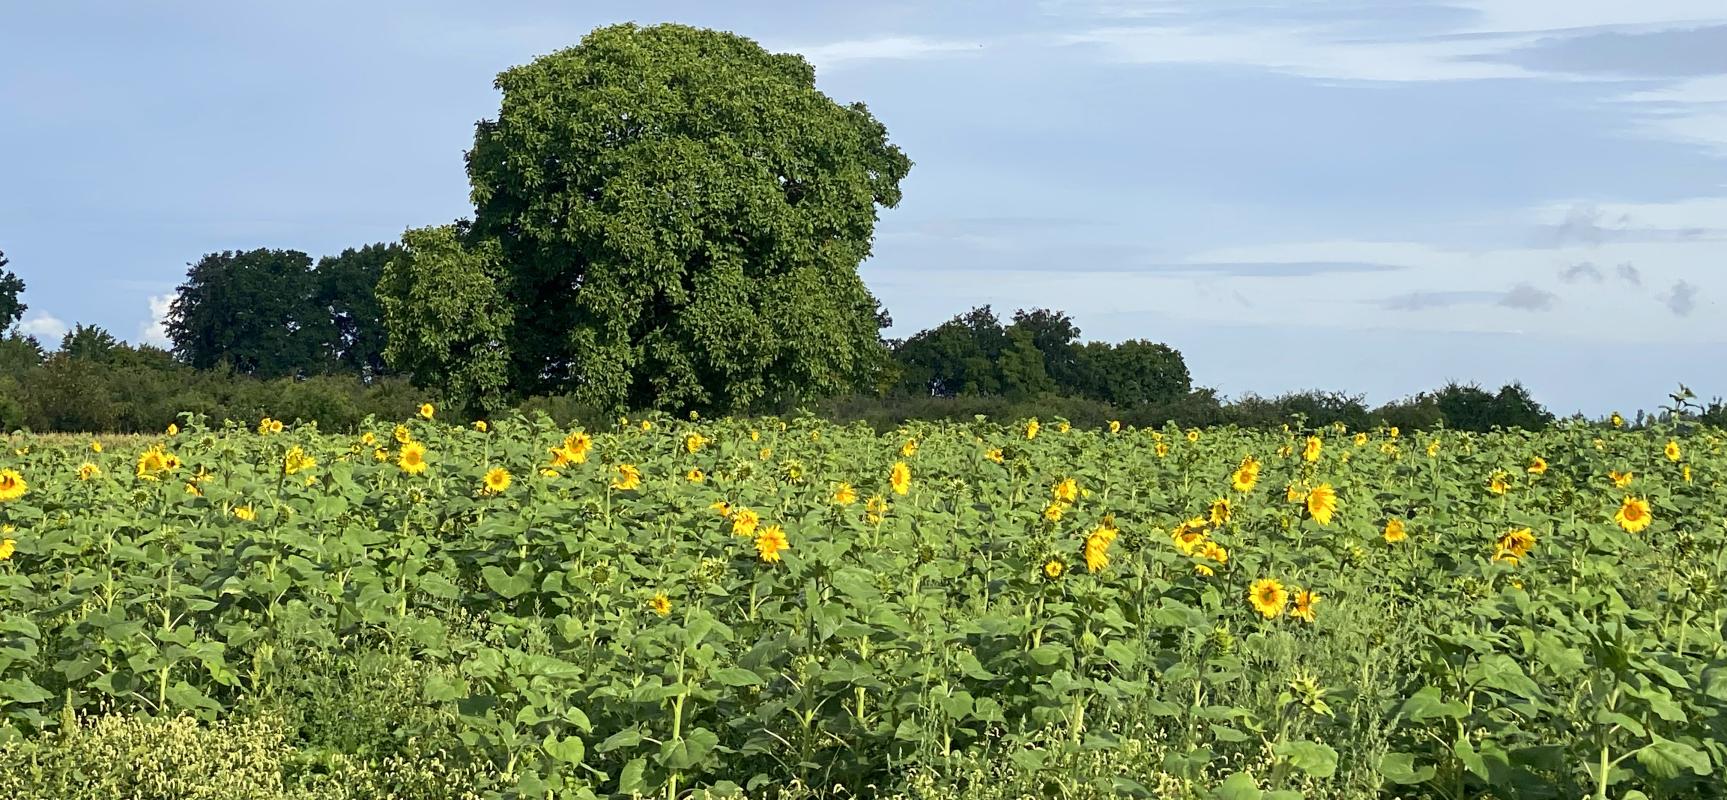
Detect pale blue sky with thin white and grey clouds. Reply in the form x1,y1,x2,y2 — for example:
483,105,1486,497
0,0,1727,415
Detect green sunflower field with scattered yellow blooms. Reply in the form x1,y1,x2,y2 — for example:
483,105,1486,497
0,406,1727,800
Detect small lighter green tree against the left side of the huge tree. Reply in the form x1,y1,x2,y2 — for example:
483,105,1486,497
378,225,513,410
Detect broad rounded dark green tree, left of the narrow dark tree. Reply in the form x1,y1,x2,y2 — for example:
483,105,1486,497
168,249,335,378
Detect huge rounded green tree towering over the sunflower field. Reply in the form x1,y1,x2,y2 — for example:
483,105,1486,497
385,24,910,411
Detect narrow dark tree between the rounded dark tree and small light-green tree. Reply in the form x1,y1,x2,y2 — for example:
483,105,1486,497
314,244,402,378
